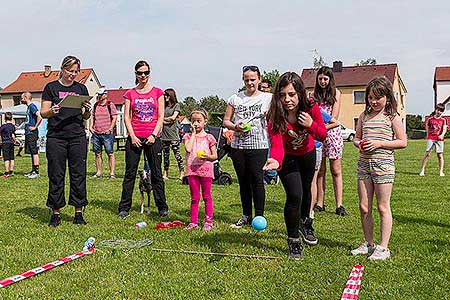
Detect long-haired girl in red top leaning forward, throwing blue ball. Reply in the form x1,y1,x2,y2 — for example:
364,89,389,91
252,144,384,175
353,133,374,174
264,72,327,259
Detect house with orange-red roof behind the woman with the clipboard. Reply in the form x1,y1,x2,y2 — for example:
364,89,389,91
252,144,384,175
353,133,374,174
0,65,101,122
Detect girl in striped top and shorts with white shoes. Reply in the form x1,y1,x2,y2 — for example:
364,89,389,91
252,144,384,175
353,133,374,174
351,77,407,260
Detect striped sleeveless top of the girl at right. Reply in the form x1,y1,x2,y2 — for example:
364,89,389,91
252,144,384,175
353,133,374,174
361,113,394,156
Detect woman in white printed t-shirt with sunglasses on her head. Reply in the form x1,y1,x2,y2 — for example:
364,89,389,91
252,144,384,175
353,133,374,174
223,66,272,228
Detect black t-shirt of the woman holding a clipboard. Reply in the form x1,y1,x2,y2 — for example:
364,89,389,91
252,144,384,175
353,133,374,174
42,80,89,139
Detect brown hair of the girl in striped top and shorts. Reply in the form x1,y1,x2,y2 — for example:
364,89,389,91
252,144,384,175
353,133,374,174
364,76,397,119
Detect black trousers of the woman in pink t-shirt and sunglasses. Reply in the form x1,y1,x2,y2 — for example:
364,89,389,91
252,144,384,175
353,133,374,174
119,137,169,212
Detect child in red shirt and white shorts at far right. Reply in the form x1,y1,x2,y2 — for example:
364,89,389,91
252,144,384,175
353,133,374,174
419,103,447,176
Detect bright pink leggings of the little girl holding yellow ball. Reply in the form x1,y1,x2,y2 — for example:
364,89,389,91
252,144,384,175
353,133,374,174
188,175,213,224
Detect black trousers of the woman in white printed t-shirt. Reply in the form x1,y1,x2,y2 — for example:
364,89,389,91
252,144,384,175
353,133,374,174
231,148,268,216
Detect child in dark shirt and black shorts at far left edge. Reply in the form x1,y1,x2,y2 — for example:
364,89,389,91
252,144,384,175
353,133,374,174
0,112,16,178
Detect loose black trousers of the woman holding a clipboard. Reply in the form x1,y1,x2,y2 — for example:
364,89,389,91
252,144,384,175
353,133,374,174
46,135,88,209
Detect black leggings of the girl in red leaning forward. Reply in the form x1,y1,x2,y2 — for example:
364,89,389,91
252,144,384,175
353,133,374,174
278,149,316,238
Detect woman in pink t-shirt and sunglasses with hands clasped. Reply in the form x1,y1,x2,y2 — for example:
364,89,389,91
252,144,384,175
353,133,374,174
119,60,169,218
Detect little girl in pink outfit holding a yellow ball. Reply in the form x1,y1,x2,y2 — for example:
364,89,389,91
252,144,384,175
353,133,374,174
183,108,217,231
